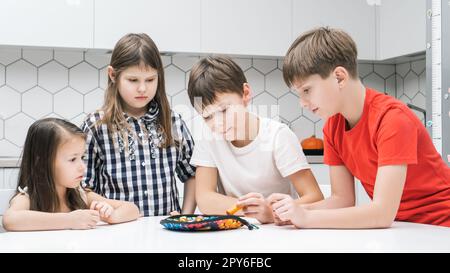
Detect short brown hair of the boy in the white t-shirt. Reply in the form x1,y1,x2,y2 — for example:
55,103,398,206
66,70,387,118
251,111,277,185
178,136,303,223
188,55,247,108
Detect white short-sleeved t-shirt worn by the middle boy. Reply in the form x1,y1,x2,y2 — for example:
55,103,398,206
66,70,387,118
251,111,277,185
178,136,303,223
190,118,310,198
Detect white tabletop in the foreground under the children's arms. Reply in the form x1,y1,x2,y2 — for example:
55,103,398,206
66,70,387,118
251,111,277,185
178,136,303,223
0,217,450,253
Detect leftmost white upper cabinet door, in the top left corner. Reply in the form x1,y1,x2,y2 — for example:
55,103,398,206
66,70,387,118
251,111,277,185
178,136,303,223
0,0,94,48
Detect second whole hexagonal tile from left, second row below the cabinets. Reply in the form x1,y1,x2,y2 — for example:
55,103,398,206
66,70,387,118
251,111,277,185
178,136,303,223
38,61,69,93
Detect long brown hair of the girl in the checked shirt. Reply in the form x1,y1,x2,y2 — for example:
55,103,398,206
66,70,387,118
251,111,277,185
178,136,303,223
101,33,174,147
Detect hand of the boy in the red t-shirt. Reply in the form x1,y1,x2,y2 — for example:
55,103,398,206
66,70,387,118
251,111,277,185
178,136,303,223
268,193,306,228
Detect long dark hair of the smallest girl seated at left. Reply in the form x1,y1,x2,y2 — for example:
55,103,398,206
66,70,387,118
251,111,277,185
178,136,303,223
16,118,87,212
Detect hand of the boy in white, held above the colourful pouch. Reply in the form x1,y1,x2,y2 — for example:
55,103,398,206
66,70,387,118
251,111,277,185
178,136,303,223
236,192,273,224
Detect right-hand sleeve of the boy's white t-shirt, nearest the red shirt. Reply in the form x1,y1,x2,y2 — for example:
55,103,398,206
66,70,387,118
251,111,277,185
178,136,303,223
274,126,311,177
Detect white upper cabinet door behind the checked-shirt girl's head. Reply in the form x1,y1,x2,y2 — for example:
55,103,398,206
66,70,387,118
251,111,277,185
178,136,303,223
94,0,200,52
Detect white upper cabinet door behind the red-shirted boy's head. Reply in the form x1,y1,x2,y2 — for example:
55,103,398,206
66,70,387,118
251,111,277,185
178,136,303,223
292,0,376,60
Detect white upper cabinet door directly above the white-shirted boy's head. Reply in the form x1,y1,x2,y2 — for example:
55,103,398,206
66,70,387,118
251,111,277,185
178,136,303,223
201,0,292,56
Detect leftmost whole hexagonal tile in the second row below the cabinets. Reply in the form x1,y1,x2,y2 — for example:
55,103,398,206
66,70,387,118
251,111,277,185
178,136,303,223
6,60,37,92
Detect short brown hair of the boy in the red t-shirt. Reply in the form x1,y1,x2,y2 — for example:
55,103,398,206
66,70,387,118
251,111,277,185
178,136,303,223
283,27,358,86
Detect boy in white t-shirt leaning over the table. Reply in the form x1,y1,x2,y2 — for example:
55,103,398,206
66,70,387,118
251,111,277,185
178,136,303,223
188,56,323,224
